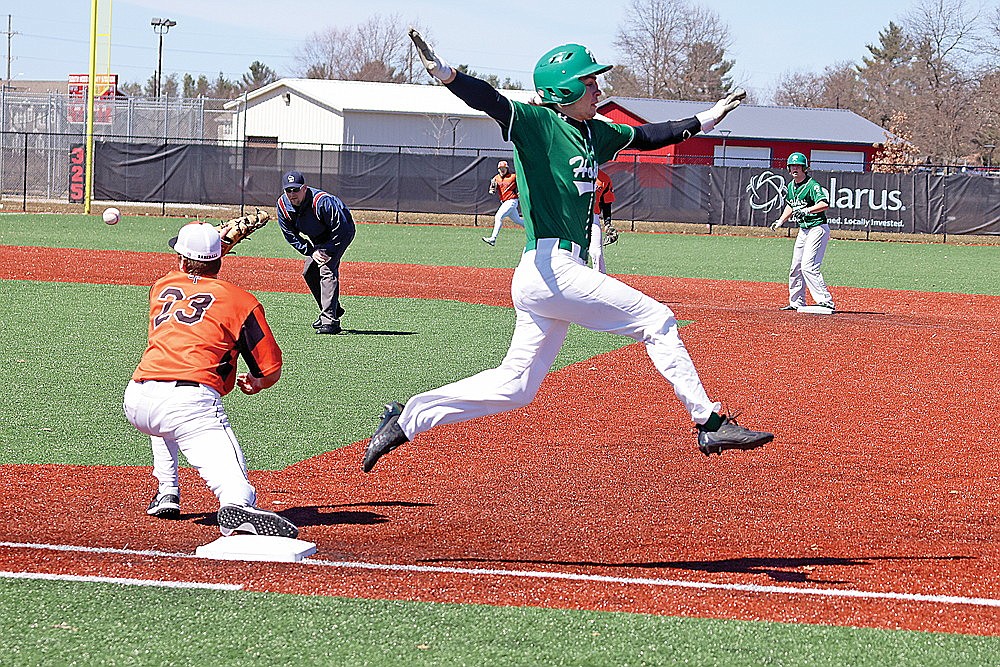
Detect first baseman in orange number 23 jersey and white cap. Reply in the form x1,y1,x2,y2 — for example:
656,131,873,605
124,223,299,537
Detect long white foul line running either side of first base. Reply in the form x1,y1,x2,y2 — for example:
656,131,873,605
0,542,1000,607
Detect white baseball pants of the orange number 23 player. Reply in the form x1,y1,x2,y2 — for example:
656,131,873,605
124,380,257,506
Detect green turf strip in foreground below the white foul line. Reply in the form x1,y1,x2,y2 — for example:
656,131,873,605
0,580,1000,667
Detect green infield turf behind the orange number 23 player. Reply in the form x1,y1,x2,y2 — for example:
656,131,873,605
0,280,632,470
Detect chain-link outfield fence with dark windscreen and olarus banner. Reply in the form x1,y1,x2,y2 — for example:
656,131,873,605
0,88,1000,235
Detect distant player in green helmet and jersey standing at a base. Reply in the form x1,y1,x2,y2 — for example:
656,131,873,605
771,153,834,312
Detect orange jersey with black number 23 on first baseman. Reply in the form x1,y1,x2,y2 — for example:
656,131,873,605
132,271,281,396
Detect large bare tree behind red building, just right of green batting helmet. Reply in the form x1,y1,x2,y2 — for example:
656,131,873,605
607,0,734,101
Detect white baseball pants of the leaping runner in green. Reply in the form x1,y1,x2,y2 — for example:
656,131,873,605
399,239,722,439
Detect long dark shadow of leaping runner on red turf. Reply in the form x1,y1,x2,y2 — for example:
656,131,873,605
420,556,973,584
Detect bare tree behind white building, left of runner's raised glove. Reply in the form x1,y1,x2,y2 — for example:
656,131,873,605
296,14,426,83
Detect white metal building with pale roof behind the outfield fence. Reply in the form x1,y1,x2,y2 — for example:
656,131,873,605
222,79,533,150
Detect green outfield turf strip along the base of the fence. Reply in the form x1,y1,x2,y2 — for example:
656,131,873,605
0,214,1000,295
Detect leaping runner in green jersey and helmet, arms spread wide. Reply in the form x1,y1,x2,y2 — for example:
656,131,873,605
362,29,773,472
